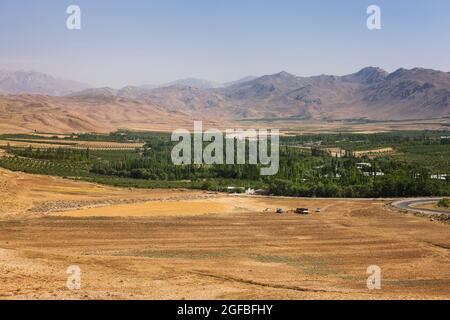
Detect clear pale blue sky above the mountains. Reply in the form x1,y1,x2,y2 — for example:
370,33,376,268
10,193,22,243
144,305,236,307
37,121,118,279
0,0,450,88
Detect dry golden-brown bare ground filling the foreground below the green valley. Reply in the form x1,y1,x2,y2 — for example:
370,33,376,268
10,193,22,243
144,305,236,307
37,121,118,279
0,169,450,299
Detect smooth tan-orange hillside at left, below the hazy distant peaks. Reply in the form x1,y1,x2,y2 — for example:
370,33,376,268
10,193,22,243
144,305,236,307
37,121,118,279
0,95,189,133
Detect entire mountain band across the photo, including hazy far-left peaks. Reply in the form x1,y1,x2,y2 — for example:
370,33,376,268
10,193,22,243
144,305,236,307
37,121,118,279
0,67,450,130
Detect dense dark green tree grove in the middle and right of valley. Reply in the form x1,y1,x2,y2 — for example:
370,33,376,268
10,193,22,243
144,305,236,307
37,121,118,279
91,145,450,197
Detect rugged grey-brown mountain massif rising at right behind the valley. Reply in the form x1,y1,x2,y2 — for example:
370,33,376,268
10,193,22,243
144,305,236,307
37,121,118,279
223,67,450,120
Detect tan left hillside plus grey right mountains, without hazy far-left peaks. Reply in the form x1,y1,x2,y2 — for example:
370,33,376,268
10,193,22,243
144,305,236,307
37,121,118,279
0,67,450,132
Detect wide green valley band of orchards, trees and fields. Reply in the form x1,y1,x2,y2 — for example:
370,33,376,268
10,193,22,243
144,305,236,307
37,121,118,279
0,131,450,198
